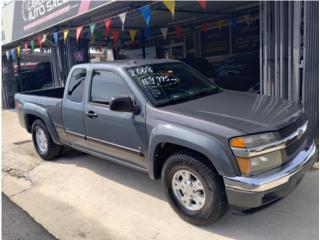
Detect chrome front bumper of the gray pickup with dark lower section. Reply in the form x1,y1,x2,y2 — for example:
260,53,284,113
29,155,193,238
224,143,316,209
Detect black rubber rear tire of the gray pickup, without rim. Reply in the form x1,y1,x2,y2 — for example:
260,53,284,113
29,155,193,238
32,119,63,160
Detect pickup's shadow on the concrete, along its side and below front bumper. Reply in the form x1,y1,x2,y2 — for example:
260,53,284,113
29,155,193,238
42,151,319,240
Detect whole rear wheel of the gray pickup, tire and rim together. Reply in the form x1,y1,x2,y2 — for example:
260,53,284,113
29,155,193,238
32,119,62,160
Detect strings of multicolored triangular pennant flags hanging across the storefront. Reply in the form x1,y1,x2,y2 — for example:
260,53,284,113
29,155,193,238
5,0,253,59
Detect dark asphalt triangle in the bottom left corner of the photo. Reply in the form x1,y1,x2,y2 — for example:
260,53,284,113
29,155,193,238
2,194,56,240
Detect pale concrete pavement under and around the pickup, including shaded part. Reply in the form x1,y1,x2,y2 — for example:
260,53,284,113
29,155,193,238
2,111,319,240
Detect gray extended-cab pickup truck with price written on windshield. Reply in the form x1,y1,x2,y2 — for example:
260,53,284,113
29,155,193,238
15,60,316,225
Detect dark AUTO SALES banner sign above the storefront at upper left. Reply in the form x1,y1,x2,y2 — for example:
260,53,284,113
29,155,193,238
12,0,109,41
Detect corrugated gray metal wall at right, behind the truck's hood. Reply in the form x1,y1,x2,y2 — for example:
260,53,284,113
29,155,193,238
260,1,319,139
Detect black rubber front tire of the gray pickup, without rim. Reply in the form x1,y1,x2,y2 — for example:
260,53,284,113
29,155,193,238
161,150,229,226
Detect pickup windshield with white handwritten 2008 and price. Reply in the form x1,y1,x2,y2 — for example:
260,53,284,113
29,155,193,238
127,62,219,106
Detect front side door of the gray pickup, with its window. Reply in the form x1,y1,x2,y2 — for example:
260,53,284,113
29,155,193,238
84,69,147,168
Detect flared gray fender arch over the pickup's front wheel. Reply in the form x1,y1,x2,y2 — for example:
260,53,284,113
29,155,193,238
148,125,235,179
